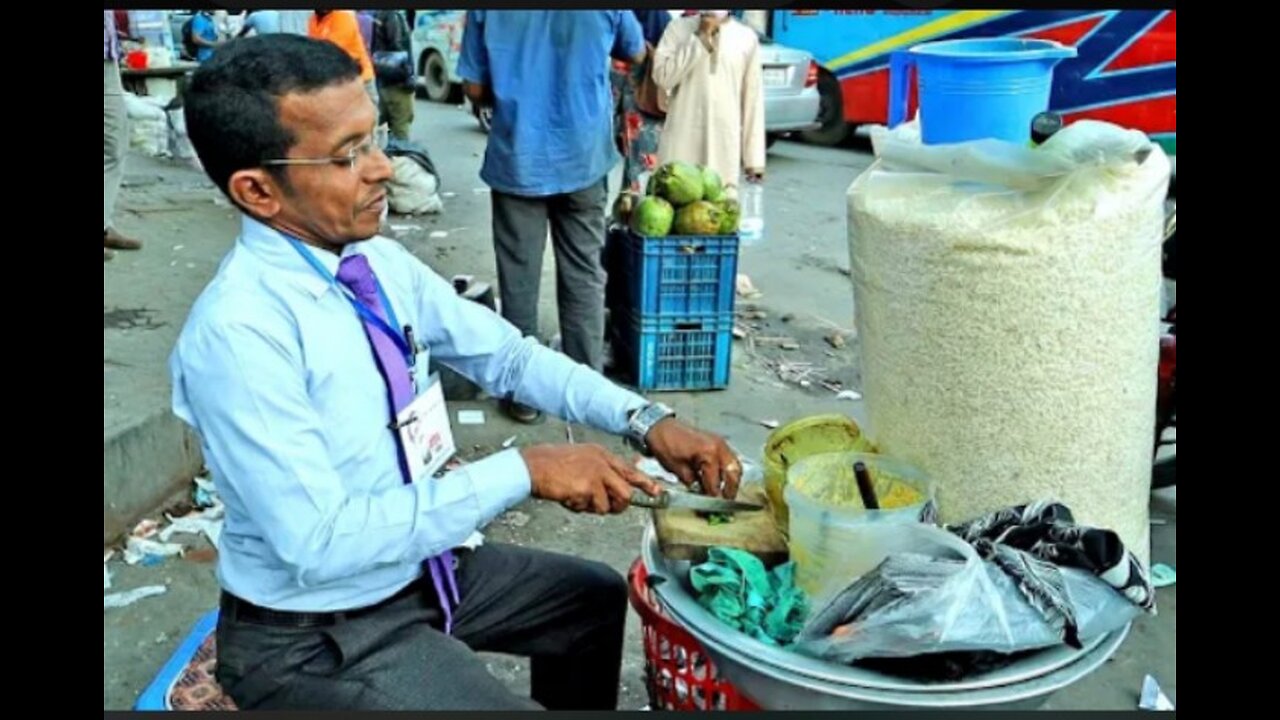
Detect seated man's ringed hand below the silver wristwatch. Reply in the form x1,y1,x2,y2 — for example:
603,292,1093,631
645,418,742,497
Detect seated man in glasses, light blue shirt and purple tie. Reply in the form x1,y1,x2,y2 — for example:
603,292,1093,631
170,35,741,710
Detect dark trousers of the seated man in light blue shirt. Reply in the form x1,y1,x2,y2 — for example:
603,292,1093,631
218,544,627,710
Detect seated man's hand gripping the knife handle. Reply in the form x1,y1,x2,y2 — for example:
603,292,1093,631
520,445,662,515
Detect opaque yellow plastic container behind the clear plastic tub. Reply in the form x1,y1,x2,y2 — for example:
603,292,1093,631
764,414,873,536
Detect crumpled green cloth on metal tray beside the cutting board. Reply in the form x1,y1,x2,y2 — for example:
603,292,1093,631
689,547,809,646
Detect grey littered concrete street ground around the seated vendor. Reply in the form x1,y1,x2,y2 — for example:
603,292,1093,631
102,101,1178,710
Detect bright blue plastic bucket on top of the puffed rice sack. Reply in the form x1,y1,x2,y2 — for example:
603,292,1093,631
888,37,1075,145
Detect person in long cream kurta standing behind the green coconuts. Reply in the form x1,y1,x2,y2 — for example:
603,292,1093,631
653,14,764,186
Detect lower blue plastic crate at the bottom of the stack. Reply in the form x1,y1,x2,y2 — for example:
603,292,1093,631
617,313,733,391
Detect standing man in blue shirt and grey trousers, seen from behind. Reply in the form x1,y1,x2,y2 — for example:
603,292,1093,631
458,10,645,421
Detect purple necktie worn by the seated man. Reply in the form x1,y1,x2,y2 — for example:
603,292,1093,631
338,255,461,633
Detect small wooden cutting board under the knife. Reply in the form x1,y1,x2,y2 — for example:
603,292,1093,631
653,486,787,566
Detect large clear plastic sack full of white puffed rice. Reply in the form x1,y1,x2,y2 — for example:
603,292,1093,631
849,122,1170,562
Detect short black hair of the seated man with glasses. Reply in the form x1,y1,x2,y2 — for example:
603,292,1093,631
183,33,360,198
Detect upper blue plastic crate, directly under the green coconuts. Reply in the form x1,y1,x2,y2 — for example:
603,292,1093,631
616,231,739,318
